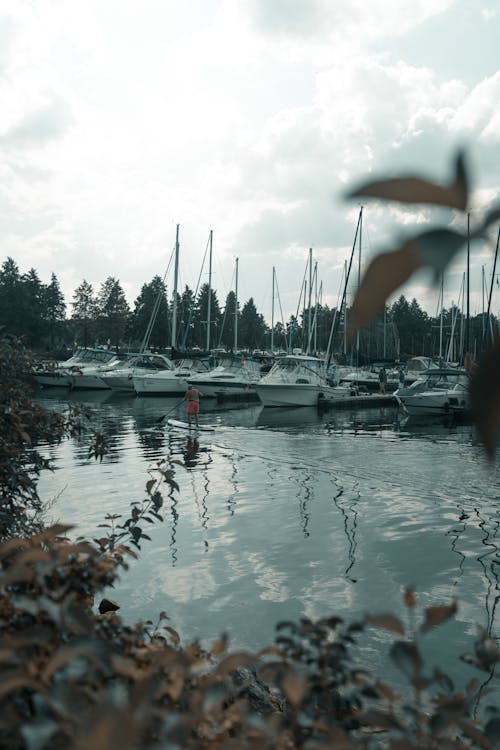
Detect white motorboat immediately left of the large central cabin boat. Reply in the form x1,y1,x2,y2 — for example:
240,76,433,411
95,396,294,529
188,357,262,398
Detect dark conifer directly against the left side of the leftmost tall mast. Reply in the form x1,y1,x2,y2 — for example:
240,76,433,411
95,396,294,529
128,276,168,348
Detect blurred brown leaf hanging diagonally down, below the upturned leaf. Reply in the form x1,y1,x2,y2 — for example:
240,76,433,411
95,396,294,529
350,243,421,336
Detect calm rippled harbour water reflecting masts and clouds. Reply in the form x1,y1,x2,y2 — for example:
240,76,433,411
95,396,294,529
34,390,500,704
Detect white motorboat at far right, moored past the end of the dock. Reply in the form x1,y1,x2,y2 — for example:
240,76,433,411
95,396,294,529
394,368,470,415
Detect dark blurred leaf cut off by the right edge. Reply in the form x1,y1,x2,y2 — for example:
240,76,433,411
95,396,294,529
470,337,500,459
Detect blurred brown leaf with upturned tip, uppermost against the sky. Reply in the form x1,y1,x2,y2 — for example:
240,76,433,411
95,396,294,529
346,151,468,211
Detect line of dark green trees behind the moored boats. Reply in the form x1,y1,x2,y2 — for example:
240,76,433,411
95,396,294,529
0,258,497,363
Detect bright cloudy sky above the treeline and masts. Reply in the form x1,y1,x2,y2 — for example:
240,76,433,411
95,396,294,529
0,0,500,323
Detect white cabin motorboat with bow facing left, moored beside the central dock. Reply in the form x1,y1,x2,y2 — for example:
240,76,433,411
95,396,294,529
255,354,351,406
